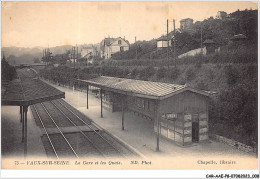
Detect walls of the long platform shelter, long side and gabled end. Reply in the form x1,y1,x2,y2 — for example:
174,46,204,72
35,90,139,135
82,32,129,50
100,91,208,145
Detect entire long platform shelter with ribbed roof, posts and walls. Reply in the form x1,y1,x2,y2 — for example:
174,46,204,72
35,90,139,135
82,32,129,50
78,76,210,150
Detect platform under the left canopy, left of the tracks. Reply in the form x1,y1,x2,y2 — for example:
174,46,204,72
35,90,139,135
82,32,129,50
1,106,46,158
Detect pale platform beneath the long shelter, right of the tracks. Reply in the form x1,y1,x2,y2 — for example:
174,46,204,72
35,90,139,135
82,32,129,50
43,80,255,158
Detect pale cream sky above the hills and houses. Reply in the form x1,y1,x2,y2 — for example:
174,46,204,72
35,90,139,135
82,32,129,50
1,1,258,47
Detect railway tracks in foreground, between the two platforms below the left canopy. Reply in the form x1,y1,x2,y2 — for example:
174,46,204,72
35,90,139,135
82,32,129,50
32,100,131,159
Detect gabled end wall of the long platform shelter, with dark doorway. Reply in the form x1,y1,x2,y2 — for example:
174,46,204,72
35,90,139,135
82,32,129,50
154,91,208,145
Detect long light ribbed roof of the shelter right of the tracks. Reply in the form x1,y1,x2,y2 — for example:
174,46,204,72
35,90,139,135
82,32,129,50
78,76,209,99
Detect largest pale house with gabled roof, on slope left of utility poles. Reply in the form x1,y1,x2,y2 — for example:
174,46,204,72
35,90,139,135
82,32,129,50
100,37,130,59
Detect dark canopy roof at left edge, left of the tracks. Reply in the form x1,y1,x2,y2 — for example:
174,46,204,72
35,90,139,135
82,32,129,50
2,69,65,105
